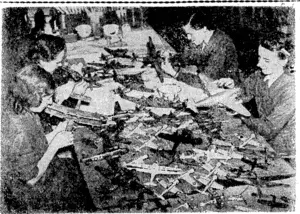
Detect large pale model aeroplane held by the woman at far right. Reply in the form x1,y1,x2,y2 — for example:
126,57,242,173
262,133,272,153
195,88,251,117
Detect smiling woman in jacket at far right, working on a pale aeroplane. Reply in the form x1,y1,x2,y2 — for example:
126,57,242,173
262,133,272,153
185,33,295,154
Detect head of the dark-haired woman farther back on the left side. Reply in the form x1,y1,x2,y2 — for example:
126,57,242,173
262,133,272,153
28,34,67,73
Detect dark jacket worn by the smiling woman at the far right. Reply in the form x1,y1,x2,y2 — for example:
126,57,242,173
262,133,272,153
243,71,296,153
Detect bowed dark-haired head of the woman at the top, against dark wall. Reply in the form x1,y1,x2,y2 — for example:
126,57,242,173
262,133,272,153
182,12,215,45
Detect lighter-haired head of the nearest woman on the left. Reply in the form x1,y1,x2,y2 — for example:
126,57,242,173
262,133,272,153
9,65,55,114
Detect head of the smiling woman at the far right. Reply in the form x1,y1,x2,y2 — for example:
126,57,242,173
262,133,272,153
257,32,291,75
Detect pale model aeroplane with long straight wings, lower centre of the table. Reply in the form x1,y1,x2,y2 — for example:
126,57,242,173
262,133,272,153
122,162,183,186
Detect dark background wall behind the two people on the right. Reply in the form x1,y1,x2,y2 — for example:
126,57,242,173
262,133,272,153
145,7,295,70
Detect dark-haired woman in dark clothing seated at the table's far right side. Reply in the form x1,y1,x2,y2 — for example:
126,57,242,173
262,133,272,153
165,12,238,83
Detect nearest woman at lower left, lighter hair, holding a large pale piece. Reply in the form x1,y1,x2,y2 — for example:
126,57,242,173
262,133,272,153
1,64,92,212
